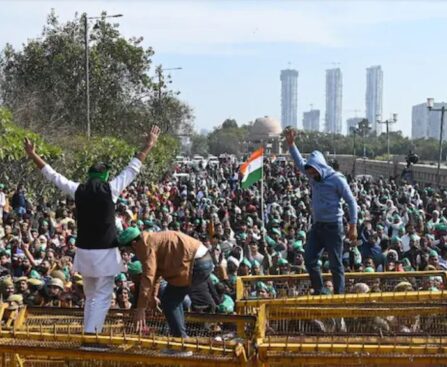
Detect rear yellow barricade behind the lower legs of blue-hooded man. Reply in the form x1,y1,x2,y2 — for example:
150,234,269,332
236,271,447,315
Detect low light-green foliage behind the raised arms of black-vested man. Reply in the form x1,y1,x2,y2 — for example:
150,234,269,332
0,108,179,201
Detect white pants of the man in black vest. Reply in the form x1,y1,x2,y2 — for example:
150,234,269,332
83,276,115,333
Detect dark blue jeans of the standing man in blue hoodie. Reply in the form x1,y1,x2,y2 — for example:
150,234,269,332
304,222,345,294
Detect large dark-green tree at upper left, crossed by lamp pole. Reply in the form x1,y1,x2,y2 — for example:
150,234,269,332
0,12,192,141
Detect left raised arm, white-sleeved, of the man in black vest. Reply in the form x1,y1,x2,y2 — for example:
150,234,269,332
24,138,79,198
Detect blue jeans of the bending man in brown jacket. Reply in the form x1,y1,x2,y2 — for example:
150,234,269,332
161,253,214,338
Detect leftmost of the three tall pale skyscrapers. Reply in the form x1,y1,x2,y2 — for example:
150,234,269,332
281,69,298,128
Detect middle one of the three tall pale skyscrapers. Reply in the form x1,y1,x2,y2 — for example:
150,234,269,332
325,68,343,134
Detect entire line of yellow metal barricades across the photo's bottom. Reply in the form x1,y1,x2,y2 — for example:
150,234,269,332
0,272,447,367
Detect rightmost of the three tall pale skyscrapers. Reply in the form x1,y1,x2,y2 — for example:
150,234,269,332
365,65,383,134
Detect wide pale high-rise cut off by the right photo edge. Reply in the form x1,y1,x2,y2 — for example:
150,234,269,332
411,102,447,140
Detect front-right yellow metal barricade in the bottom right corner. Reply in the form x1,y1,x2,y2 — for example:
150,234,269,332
256,299,447,367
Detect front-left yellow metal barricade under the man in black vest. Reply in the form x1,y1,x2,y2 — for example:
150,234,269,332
0,308,256,367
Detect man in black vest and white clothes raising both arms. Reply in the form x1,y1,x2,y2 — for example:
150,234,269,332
24,126,160,340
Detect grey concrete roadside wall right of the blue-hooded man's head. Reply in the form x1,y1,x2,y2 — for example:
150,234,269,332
337,155,447,187
